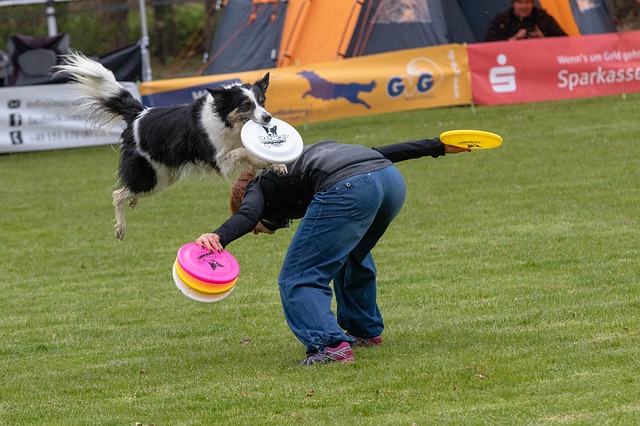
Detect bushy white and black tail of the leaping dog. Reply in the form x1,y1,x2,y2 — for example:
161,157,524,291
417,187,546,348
56,52,145,131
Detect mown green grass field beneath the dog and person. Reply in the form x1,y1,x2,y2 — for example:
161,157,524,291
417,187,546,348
0,94,640,426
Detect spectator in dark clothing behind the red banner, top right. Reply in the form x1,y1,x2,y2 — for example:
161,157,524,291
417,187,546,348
485,0,567,41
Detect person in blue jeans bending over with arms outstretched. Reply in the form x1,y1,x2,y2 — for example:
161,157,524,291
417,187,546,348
195,138,468,365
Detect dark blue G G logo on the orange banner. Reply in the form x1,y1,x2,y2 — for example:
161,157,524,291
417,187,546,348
387,58,444,98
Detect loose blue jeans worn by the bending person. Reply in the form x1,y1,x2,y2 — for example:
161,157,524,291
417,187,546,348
278,166,406,353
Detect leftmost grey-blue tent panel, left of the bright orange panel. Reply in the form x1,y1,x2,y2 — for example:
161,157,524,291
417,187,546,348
206,0,287,74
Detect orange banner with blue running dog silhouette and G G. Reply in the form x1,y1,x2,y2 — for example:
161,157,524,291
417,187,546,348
140,44,471,124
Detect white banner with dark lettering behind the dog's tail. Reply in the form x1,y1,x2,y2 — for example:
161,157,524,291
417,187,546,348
0,82,140,153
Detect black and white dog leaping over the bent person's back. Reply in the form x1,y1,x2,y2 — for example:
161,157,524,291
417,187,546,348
57,52,287,239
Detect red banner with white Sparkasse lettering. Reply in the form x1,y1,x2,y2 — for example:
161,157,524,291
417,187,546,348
467,31,640,105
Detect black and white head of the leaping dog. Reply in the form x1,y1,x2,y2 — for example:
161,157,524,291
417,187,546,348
207,73,271,128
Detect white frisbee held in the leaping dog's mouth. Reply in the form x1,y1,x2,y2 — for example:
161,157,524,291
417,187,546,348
240,118,303,164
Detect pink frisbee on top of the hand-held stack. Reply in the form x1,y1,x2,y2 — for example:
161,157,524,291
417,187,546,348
177,243,240,284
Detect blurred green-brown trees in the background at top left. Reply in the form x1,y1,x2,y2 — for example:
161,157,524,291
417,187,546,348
0,0,217,68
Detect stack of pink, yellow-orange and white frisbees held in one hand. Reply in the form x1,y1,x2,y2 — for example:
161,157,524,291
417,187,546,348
173,243,240,302
